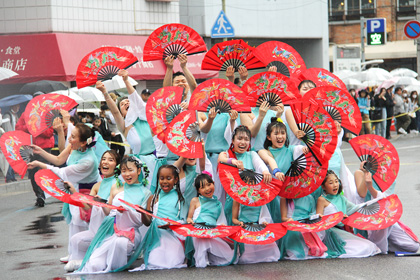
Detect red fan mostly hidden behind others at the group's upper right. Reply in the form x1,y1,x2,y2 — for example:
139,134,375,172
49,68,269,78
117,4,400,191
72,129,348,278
299,68,347,90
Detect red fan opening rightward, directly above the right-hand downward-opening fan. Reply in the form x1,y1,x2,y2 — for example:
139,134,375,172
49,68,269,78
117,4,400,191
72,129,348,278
291,98,337,165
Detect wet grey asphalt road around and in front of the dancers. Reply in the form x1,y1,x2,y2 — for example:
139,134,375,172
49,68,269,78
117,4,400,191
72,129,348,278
0,135,420,280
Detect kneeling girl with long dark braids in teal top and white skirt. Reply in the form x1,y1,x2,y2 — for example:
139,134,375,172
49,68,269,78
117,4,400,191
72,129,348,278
132,165,188,271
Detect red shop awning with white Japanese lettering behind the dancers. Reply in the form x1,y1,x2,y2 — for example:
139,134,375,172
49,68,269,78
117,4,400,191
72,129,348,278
0,33,218,84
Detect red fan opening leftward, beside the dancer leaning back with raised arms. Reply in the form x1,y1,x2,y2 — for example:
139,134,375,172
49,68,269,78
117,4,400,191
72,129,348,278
146,87,184,142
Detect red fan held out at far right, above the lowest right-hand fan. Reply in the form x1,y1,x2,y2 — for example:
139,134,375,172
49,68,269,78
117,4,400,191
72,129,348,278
349,134,400,192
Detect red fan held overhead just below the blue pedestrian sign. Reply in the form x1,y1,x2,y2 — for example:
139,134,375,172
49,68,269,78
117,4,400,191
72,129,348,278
201,40,265,71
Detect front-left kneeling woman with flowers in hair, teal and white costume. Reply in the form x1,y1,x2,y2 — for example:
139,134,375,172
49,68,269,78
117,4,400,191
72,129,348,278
75,156,152,274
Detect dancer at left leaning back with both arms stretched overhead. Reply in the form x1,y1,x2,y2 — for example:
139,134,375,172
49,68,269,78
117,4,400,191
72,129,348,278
96,70,156,188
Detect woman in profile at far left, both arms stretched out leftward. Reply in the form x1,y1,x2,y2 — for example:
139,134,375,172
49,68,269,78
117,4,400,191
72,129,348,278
28,124,101,262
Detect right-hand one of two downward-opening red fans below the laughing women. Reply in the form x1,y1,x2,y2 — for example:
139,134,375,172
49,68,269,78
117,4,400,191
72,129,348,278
279,153,328,199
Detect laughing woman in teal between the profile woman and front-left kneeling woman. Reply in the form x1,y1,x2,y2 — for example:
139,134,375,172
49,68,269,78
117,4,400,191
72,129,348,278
64,150,120,272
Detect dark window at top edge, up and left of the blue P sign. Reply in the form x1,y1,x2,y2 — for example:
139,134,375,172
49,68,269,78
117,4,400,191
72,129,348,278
328,0,378,21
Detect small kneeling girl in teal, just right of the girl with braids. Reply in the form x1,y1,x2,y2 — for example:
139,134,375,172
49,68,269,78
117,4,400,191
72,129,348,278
185,173,233,267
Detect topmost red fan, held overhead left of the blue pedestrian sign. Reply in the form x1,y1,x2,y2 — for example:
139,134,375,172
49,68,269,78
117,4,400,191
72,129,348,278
143,23,207,61
